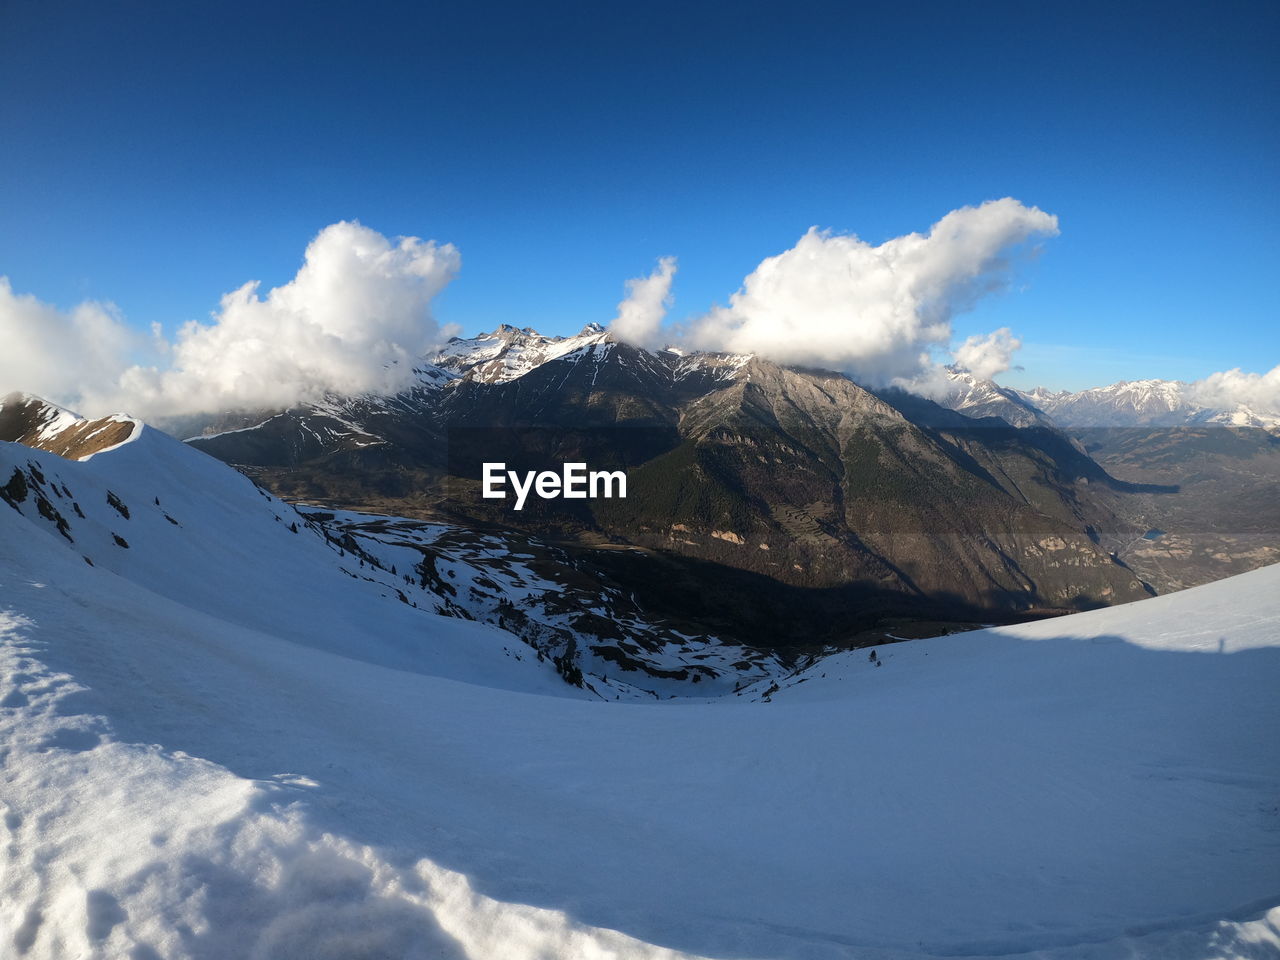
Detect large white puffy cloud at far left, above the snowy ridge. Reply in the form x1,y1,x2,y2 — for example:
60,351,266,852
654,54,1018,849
0,221,461,417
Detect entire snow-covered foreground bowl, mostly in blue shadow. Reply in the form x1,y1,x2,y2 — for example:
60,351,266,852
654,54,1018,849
0,430,1280,960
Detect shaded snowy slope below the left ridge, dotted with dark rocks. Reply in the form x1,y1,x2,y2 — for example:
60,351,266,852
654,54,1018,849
0,425,572,695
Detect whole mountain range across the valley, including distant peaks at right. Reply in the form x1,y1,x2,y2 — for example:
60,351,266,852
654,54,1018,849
0,324,1280,652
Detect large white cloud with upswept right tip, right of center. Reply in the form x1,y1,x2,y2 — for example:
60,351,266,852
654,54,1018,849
687,197,1057,385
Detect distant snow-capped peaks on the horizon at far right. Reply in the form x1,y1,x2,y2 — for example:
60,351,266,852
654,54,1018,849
1021,380,1280,429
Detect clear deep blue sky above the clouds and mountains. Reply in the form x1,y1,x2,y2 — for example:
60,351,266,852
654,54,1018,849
0,0,1280,388
